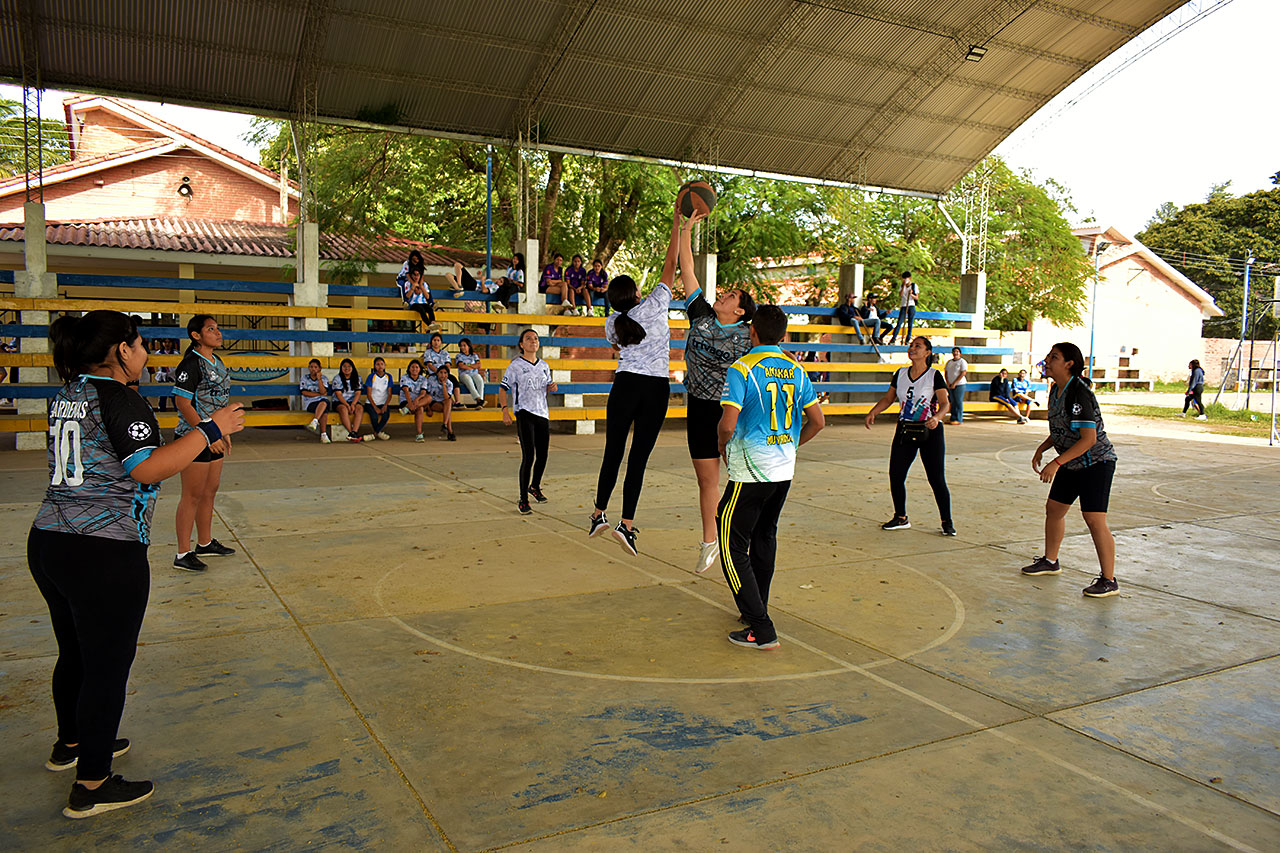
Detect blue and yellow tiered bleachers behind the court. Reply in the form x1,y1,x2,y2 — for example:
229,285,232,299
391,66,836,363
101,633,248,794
0,270,1043,432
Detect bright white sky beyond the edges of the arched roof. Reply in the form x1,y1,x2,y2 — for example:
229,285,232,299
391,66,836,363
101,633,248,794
0,0,1280,236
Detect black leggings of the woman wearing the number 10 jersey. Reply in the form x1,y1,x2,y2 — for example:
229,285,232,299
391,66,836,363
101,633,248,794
27,528,151,781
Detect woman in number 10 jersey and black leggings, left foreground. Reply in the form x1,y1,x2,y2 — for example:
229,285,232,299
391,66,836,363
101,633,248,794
27,311,244,817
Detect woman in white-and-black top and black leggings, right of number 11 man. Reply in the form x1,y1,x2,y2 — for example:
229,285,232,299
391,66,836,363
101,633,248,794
867,336,956,537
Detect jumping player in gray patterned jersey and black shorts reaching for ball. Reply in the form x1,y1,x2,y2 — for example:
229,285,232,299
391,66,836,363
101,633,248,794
680,227,755,574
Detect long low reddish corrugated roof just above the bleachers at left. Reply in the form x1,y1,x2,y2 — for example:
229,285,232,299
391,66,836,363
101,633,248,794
0,216,508,268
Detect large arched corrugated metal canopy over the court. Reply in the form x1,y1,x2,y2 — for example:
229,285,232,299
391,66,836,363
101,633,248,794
0,0,1183,195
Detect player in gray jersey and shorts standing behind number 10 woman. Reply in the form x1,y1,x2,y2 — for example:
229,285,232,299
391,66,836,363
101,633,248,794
173,314,236,571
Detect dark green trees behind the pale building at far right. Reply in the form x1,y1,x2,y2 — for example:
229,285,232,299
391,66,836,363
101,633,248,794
1137,182,1280,338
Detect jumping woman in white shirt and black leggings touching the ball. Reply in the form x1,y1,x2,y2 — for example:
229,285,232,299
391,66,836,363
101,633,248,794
588,202,707,556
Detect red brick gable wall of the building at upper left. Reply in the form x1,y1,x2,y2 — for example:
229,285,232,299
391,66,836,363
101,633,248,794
0,149,297,223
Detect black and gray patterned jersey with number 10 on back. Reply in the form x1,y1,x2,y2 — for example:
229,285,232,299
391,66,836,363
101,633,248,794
33,375,163,544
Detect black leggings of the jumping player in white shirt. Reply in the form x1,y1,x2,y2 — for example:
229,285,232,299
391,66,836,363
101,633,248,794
595,373,671,520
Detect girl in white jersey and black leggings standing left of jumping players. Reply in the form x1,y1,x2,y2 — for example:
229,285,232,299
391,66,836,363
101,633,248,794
498,329,557,515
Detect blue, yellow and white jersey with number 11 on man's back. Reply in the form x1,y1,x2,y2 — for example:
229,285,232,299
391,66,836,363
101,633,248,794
721,346,818,483
